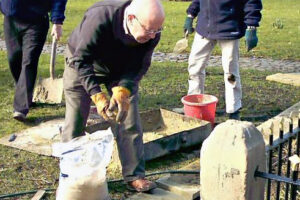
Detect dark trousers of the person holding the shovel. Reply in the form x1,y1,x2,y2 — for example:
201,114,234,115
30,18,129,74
4,17,49,115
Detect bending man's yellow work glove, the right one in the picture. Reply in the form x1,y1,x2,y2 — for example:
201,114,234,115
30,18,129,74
107,86,130,123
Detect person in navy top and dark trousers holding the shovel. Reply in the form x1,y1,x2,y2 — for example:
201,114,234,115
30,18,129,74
0,0,67,121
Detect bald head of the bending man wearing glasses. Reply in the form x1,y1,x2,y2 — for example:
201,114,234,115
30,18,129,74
127,0,165,43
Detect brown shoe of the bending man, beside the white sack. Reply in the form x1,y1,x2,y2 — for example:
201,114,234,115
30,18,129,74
127,179,157,192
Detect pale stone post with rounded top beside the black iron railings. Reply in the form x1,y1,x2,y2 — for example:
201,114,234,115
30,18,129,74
200,120,266,200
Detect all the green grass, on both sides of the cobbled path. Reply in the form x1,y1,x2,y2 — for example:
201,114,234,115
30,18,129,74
0,0,300,199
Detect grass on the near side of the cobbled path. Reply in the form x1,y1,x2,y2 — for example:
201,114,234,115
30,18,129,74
0,49,300,199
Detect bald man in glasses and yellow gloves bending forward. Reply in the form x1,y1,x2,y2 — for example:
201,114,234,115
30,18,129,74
62,0,165,192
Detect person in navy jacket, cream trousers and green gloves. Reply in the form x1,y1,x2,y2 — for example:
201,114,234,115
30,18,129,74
179,0,262,120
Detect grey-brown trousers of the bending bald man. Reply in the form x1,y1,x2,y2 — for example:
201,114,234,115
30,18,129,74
62,66,145,182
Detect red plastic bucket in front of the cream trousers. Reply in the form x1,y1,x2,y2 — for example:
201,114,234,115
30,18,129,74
181,94,218,125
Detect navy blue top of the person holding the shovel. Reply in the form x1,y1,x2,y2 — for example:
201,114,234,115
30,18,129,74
0,0,67,24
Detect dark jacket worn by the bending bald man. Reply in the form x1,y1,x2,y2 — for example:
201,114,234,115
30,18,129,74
67,0,160,95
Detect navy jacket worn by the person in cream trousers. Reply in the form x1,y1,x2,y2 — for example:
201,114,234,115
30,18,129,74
187,0,262,40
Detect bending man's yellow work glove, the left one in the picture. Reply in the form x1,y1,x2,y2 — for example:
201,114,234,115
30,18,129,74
91,92,109,120
